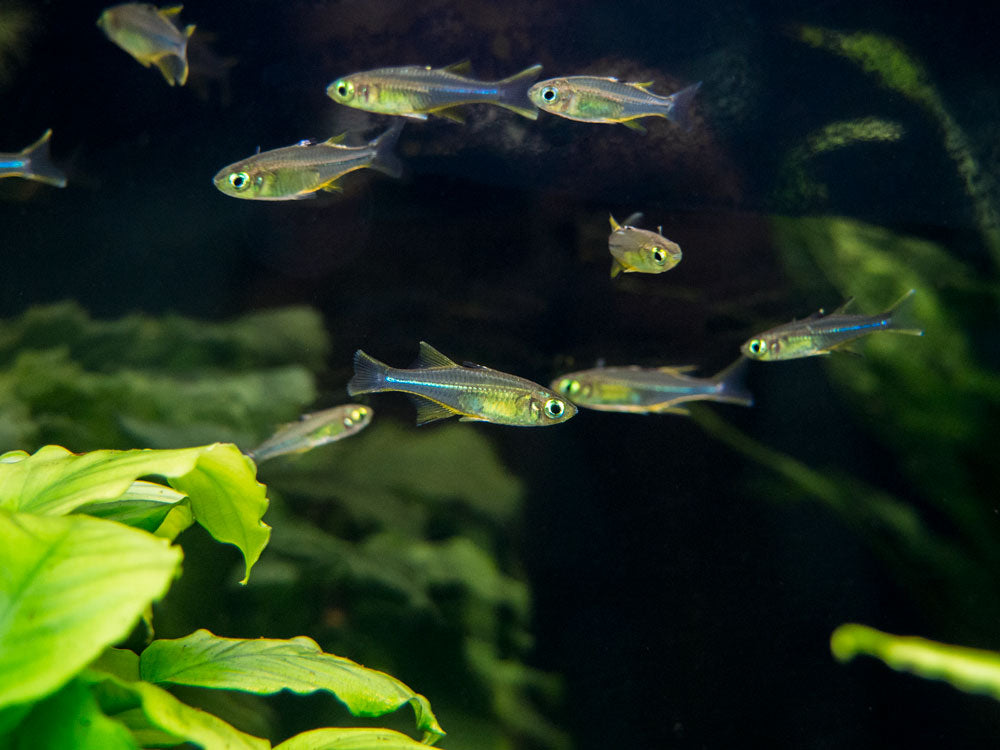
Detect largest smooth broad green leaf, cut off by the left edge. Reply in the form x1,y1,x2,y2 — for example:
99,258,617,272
0,510,181,707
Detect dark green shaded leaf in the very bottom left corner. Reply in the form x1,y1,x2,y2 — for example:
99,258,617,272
0,680,139,750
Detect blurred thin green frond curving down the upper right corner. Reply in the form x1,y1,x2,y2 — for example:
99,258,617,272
793,25,1000,267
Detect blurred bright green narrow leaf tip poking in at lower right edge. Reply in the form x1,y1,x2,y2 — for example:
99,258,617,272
830,623,1000,700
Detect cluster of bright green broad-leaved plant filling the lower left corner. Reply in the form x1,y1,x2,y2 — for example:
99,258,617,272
0,444,443,750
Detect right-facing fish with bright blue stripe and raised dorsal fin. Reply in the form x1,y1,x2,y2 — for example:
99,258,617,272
347,341,576,427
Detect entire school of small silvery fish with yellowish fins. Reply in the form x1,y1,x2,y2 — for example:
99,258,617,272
0,3,923,446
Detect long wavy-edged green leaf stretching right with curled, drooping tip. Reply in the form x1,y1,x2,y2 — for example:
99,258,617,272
139,630,444,738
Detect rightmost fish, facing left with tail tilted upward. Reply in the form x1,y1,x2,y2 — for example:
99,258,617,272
741,289,924,362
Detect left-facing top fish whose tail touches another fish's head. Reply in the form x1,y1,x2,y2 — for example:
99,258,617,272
326,62,542,122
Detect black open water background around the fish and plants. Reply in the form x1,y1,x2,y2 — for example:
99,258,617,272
0,0,1000,748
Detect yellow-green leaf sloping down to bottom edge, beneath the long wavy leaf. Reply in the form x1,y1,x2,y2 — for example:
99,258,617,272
82,670,271,750
